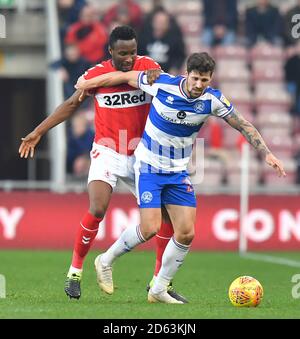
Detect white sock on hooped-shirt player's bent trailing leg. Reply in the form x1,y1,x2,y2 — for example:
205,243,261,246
101,225,146,266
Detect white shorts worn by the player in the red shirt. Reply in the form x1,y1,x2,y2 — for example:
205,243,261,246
88,142,136,196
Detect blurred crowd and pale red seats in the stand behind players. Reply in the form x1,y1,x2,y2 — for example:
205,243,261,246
56,0,300,185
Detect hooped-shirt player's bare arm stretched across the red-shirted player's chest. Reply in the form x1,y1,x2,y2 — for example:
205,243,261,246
75,71,140,90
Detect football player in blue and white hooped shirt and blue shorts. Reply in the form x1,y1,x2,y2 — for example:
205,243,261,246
77,53,285,303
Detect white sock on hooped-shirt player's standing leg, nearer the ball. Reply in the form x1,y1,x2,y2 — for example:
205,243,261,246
151,236,190,293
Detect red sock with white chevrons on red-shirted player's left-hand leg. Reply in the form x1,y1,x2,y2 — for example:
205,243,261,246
72,212,102,269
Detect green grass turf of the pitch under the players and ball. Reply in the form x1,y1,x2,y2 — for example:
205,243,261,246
0,251,300,319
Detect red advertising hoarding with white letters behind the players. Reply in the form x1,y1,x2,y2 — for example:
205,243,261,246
0,192,300,250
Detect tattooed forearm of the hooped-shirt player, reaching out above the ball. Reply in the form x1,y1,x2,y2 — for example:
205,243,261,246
224,109,286,177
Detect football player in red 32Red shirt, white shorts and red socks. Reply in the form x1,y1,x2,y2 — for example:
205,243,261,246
19,26,187,302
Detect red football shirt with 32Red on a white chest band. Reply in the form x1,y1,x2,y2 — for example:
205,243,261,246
84,56,160,155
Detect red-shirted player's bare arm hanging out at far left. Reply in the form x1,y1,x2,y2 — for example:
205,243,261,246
19,90,85,158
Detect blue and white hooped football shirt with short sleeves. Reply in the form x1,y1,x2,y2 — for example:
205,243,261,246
135,72,233,172
